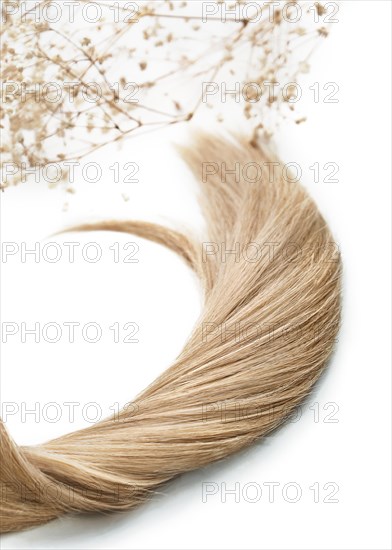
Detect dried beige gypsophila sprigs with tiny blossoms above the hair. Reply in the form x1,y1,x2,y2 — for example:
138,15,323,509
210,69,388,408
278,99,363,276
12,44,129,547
0,0,328,189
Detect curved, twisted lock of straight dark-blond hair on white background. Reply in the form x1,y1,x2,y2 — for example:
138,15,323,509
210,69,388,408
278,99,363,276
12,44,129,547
0,135,341,532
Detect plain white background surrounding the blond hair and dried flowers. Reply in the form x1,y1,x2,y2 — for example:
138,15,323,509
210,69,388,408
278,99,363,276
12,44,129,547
1,1,391,549
